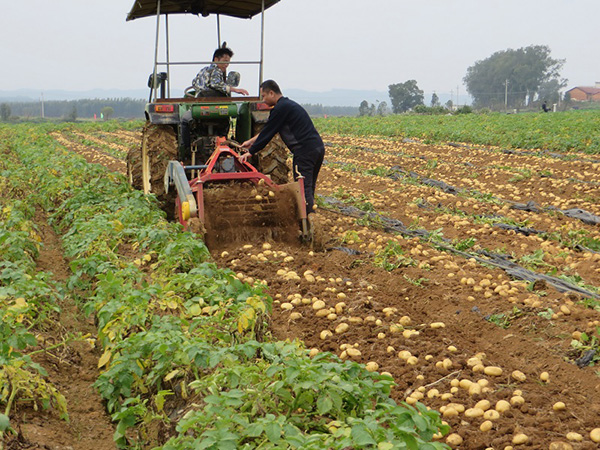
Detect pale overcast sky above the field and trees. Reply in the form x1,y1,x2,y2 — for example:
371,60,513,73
0,0,600,102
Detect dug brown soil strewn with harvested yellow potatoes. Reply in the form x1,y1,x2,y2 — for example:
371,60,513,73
55,126,600,450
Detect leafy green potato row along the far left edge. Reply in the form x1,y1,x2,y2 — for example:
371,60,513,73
0,148,68,448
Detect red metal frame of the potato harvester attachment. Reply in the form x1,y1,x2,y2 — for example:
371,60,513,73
175,137,307,227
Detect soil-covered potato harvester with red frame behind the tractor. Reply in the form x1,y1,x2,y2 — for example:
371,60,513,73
164,137,311,247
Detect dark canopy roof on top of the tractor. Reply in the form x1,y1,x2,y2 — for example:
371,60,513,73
127,0,279,20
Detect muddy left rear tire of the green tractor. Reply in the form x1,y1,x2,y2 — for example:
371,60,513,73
127,122,178,200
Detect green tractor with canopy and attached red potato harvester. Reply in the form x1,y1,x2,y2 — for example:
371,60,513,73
122,0,310,243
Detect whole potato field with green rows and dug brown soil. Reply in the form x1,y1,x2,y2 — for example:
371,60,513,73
0,112,600,450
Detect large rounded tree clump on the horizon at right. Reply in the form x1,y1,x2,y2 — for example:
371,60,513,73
464,45,566,108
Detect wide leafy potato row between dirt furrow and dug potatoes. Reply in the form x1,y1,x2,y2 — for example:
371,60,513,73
0,121,446,449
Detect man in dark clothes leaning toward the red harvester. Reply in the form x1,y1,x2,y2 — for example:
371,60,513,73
240,80,325,214
